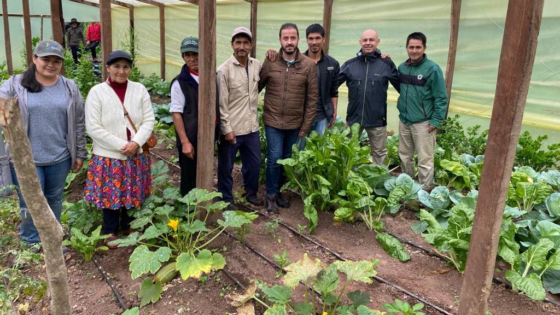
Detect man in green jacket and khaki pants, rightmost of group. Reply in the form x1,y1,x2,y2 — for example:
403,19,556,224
397,32,447,191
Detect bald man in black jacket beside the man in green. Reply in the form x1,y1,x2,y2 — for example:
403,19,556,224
338,30,400,165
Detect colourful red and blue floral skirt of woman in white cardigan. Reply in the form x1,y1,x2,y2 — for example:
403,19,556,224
84,154,152,210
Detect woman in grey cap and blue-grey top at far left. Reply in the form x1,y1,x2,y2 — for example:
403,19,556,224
0,40,87,248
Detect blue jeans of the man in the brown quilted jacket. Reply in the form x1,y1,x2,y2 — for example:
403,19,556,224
264,126,299,196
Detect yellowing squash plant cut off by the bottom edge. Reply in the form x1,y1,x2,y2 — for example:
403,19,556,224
227,254,382,315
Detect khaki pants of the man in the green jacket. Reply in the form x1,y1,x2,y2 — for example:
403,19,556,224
399,121,436,189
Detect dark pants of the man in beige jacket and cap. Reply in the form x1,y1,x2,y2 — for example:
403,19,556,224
218,131,261,202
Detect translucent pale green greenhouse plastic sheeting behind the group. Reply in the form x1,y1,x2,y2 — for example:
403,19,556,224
0,0,560,142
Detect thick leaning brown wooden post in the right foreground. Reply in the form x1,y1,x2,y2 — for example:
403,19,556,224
458,0,544,315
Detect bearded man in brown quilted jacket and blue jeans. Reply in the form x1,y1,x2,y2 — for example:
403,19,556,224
259,23,319,212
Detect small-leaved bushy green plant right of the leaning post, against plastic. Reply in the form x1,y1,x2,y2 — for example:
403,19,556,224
515,131,560,172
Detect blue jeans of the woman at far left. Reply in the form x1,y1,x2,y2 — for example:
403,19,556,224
10,159,72,244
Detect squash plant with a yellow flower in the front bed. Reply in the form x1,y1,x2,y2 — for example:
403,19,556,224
111,188,256,306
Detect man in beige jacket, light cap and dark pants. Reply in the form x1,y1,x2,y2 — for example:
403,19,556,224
217,27,262,210
